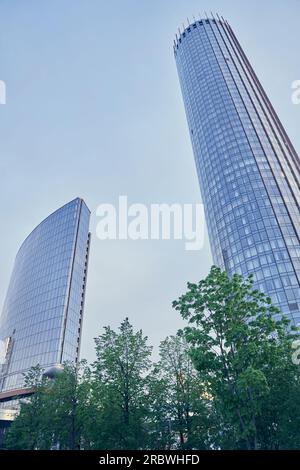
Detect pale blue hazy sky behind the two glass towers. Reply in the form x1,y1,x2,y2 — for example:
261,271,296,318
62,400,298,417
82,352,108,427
0,0,300,360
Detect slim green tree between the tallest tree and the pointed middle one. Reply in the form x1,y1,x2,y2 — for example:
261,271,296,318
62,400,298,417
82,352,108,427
151,336,209,449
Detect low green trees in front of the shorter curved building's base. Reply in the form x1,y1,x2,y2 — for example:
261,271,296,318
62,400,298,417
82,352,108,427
5,361,91,449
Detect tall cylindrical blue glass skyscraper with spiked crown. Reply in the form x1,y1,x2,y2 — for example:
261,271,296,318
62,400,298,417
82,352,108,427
174,17,300,324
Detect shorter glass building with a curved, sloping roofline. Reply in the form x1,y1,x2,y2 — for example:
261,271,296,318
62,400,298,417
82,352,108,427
0,198,90,392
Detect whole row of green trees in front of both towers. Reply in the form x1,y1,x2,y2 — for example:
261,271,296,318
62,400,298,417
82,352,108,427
5,267,300,449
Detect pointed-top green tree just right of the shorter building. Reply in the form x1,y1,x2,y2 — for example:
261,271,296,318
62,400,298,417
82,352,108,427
93,318,152,449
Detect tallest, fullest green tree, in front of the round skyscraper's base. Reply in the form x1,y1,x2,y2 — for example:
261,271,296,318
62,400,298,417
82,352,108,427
173,267,299,449
